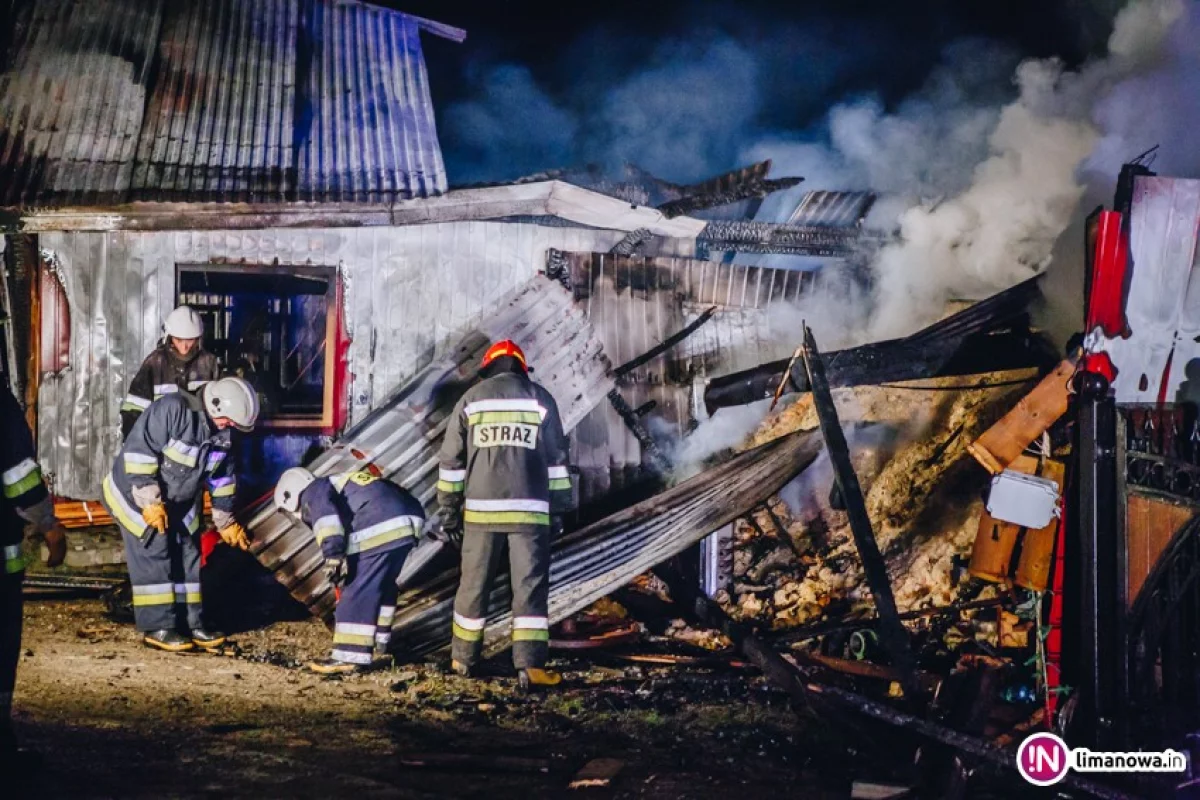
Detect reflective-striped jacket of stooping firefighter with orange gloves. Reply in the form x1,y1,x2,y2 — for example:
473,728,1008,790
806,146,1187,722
102,393,238,539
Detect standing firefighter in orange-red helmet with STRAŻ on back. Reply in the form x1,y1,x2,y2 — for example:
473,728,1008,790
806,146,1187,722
438,339,571,686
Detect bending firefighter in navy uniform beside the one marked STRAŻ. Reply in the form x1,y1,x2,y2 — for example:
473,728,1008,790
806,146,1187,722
275,467,425,674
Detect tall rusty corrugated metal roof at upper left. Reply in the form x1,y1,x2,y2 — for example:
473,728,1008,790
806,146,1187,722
0,0,452,206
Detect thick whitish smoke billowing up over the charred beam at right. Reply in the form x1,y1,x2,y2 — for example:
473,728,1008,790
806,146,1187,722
746,0,1200,341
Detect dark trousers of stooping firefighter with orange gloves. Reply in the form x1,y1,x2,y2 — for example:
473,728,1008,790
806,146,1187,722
121,504,204,633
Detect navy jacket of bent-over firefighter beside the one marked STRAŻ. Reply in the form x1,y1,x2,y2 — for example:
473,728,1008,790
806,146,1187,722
300,470,425,558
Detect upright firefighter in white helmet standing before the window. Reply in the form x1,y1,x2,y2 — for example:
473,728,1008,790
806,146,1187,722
121,306,220,439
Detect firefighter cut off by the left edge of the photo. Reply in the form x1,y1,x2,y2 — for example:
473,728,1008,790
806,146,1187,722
0,387,67,766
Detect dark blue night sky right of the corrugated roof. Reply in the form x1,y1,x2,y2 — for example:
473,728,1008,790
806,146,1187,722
384,0,1121,185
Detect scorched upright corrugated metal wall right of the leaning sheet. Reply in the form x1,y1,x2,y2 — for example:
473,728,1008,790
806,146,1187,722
566,253,818,501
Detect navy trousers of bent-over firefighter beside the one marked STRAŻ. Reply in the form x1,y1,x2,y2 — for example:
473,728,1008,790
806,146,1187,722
332,541,413,664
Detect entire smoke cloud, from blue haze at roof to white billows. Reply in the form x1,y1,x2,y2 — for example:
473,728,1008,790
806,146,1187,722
448,0,1200,347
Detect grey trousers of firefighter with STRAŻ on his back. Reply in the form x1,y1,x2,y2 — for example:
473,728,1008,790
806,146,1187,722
450,531,550,669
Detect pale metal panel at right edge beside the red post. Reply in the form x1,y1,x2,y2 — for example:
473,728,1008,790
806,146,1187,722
1105,176,1200,403
